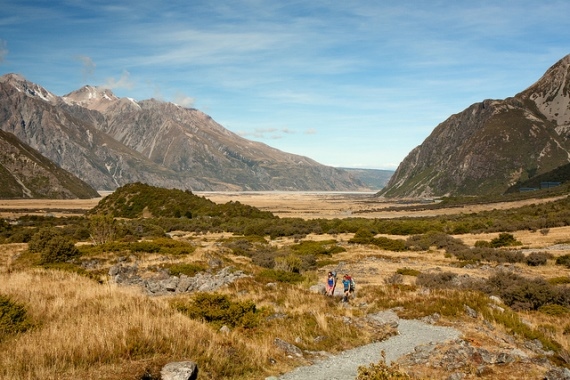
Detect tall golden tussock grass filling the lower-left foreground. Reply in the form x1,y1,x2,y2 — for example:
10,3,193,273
0,270,270,379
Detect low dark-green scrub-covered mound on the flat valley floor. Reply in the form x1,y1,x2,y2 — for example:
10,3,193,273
89,183,274,219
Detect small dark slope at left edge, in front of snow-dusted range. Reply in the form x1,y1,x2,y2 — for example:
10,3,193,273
0,130,99,199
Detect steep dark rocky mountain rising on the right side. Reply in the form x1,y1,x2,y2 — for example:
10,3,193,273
379,55,570,197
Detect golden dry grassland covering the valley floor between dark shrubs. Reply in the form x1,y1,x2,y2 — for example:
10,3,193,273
0,193,570,380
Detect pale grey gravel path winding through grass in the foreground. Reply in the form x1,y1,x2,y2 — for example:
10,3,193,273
268,319,460,380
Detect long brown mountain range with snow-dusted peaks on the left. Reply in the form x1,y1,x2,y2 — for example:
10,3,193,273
0,74,364,191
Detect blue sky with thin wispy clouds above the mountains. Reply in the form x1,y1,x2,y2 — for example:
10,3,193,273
0,0,570,169
